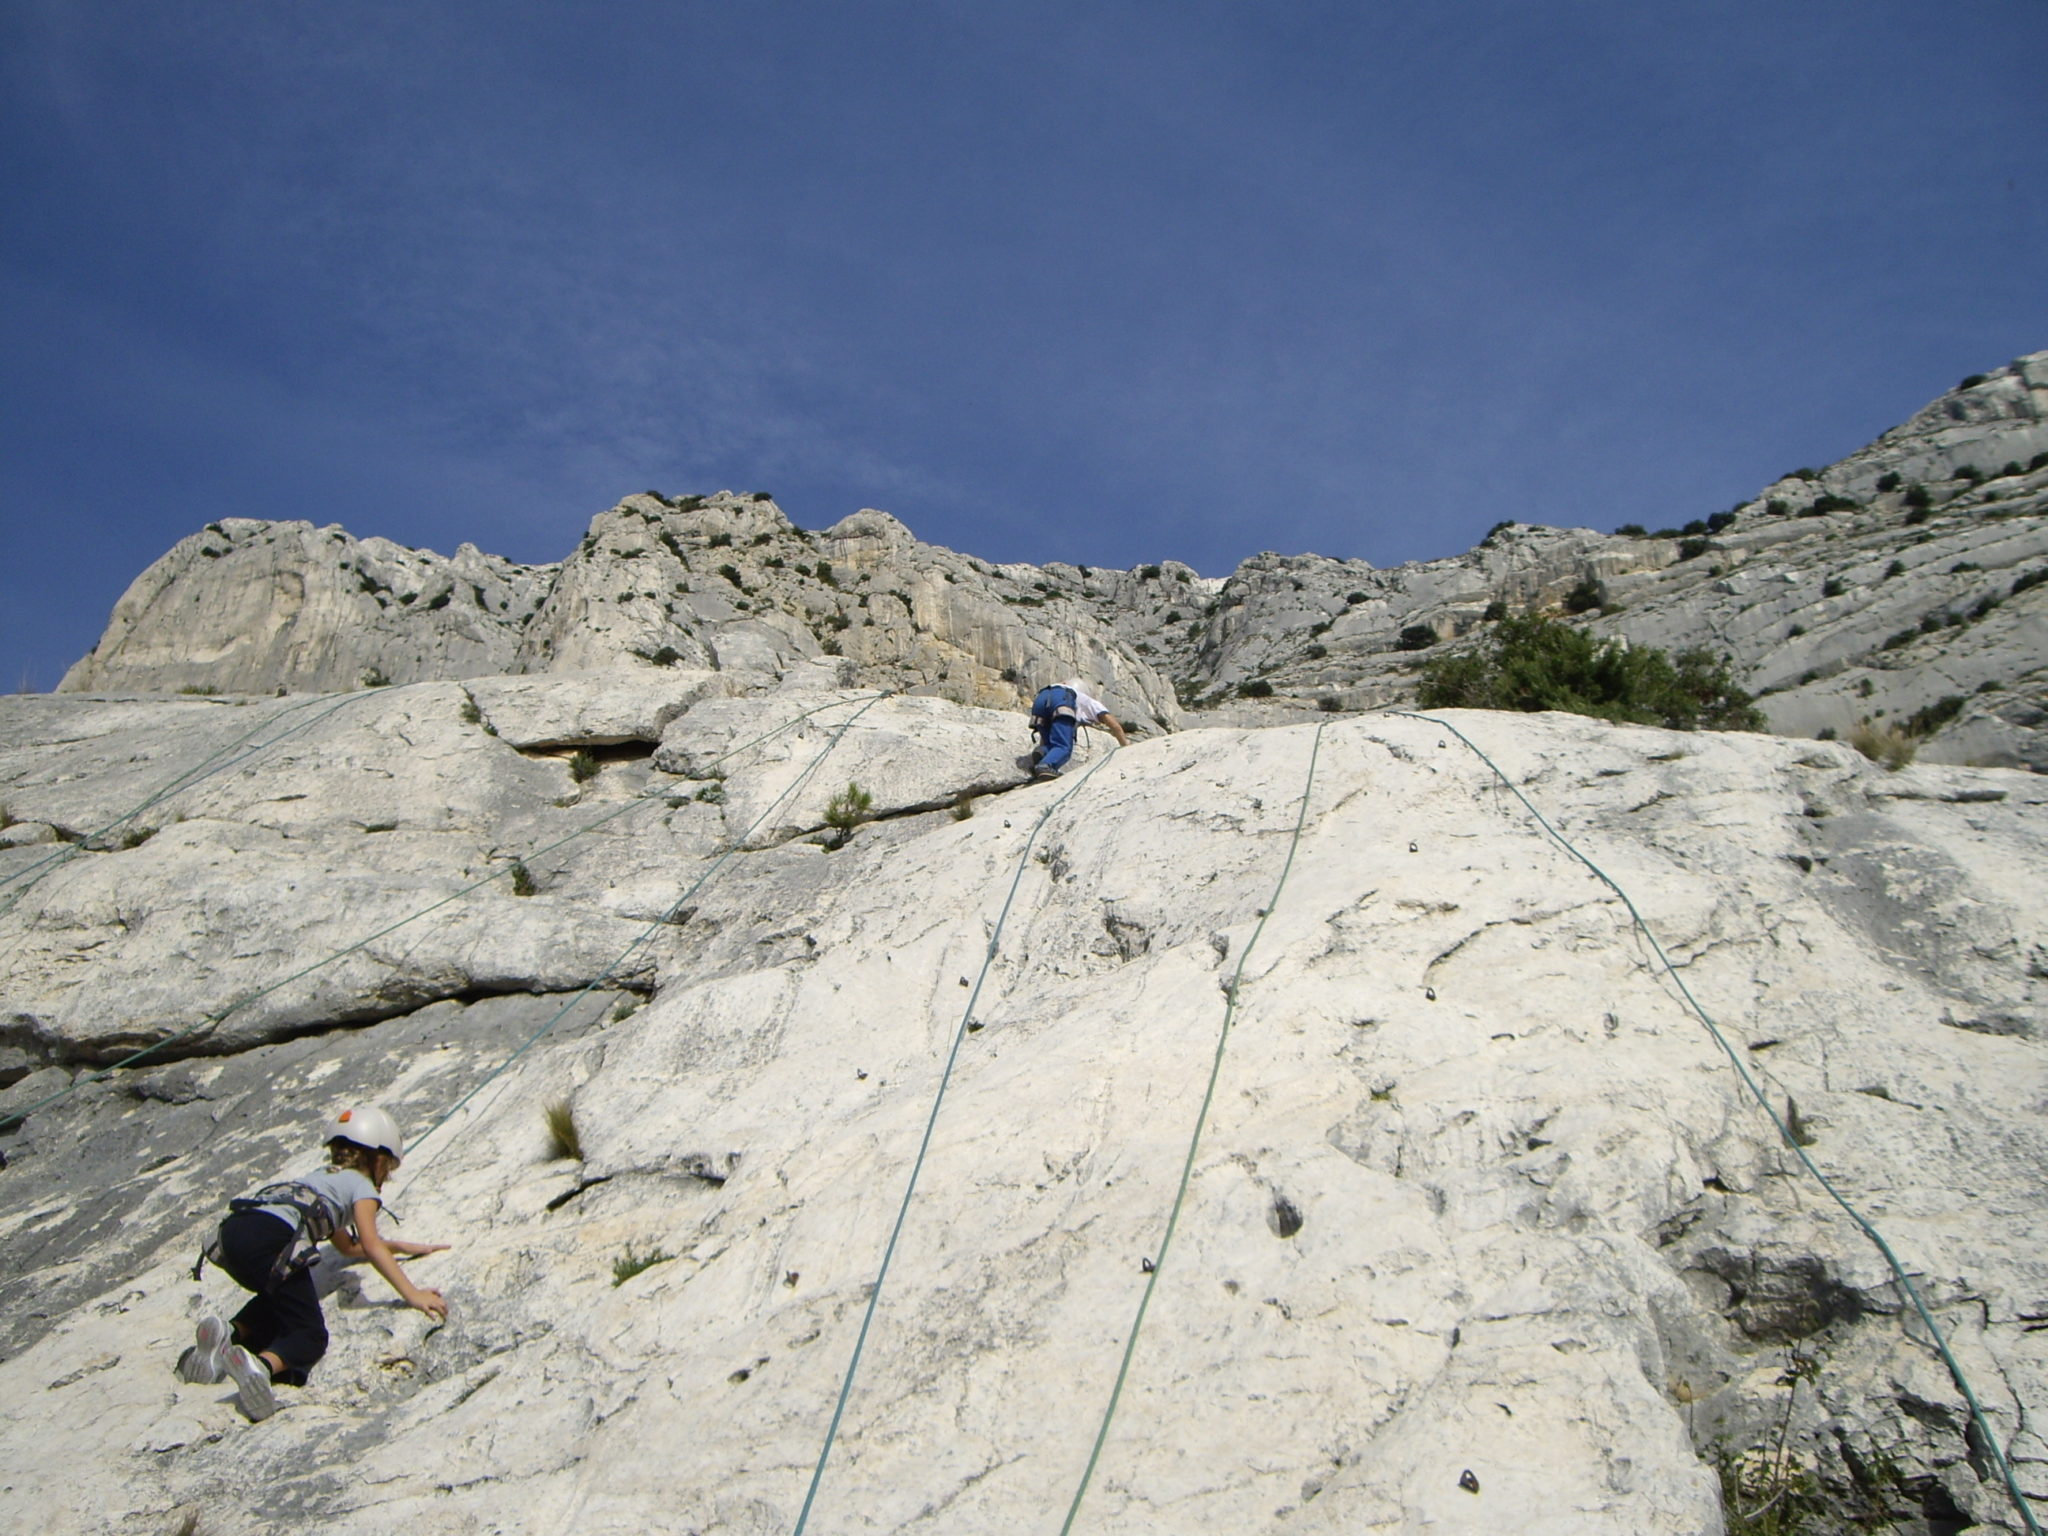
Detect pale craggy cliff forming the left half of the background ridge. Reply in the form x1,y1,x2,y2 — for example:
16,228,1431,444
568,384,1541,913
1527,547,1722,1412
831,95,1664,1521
59,492,1180,727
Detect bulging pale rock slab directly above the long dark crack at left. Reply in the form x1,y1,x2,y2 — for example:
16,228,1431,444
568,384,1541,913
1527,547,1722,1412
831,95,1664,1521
0,821,653,1061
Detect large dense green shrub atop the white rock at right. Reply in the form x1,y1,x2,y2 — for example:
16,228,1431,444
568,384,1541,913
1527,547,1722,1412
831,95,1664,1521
1421,616,1763,731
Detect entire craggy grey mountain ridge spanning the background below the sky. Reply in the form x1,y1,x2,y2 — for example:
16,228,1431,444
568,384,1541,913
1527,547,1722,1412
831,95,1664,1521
61,352,2048,770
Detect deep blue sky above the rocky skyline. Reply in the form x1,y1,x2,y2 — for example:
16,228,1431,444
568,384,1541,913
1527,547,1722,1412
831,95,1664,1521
0,0,2048,688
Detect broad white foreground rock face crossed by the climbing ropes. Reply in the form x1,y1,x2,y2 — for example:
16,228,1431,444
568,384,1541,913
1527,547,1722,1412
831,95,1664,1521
0,688,2048,1536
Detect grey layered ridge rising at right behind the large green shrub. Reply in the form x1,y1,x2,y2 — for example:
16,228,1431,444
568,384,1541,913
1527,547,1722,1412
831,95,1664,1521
1176,352,2048,772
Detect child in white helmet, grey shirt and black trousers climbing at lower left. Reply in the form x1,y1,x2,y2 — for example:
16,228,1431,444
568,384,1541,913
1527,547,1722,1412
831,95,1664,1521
178,1106,449,1419
